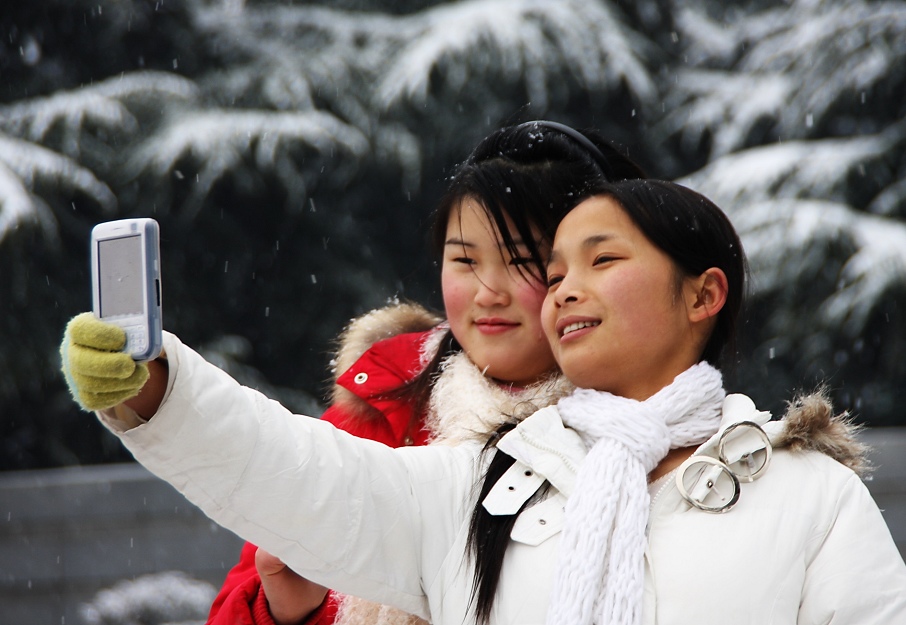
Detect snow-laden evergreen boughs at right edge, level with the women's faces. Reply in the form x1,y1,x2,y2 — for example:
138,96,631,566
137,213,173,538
681,127,906,336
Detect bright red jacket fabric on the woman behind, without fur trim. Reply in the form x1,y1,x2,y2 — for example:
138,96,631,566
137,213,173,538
207,333,427,625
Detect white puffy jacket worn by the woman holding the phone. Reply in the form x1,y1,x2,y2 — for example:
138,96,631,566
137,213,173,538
101,335,906,625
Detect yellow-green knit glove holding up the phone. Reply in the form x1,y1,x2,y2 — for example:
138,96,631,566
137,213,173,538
60,313,148,410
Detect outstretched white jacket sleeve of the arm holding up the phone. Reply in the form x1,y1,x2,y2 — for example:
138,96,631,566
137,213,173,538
105,335,478,617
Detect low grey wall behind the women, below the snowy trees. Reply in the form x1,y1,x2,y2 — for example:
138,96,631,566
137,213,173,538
0,428,906,625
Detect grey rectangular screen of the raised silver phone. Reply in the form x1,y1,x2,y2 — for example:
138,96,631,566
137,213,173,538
98,235,143,318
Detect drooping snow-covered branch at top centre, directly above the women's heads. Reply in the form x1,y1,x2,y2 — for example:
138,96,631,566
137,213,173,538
376,0,655,109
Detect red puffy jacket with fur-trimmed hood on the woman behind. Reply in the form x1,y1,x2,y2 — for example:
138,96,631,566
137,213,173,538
207,304,438,625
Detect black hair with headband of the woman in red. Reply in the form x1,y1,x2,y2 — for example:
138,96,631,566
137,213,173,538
399,120,645,419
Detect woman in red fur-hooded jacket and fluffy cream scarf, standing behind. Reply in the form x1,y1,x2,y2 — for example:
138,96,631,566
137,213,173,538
208,121,644,625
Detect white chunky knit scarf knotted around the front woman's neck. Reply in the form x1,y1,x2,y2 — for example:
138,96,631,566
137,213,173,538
547,363,725,625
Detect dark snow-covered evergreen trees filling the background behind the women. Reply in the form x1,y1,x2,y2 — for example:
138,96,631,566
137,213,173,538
0,0,906,470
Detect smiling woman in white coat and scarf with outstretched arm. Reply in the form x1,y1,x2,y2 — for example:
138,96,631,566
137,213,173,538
60,181,906,625
